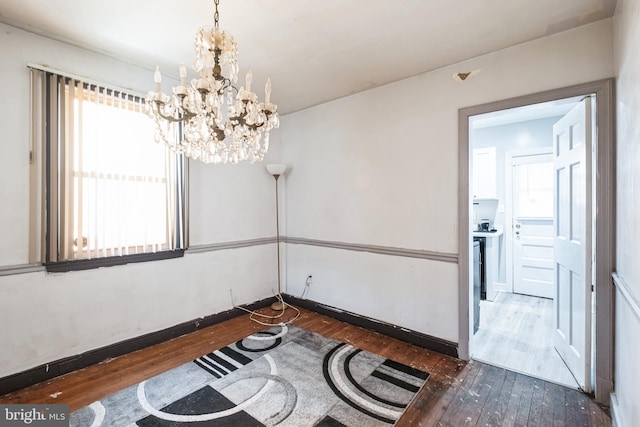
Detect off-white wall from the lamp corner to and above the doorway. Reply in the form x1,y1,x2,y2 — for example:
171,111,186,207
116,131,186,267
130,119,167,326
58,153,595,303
281,19,613,342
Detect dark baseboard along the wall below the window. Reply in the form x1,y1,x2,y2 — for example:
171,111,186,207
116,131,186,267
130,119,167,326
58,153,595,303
0,297,275,395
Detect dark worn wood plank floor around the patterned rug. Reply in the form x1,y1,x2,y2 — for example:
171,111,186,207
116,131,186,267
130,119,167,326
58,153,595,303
0,310,611,427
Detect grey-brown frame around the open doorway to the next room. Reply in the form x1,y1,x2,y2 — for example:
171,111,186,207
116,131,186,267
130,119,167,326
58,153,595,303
458,78,615,404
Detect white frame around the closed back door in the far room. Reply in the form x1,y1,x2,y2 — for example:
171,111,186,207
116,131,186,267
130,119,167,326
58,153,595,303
504,149,553,293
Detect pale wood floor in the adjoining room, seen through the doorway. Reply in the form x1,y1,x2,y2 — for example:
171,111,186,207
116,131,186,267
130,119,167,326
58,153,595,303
471,292,578,388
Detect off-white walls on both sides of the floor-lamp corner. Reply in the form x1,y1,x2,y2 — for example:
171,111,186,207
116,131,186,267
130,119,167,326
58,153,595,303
0,20,613,382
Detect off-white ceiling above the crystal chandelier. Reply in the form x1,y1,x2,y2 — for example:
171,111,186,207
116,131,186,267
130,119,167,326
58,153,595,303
0,0,616,114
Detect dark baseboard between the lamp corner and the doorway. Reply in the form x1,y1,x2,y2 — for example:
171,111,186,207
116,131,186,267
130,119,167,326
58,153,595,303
284,294,458,358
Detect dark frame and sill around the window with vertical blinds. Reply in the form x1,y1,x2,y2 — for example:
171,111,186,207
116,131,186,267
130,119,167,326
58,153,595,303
28,64,188,272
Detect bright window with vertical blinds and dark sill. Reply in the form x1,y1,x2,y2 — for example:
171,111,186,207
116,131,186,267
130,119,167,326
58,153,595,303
31,69,185,271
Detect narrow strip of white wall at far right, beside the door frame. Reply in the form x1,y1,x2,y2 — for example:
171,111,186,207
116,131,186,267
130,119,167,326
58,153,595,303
612,0,640,427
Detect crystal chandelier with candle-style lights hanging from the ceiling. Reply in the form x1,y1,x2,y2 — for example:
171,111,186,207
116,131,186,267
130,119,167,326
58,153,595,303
147,0,279,164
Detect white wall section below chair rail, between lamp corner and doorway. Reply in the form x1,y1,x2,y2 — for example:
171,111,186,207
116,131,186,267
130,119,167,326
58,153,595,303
287,245,458,339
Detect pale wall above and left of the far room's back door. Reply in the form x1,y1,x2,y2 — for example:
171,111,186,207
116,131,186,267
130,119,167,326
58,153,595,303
469,117,560,289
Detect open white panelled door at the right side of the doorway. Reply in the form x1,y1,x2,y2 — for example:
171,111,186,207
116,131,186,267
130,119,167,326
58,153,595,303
553,98,592,392
